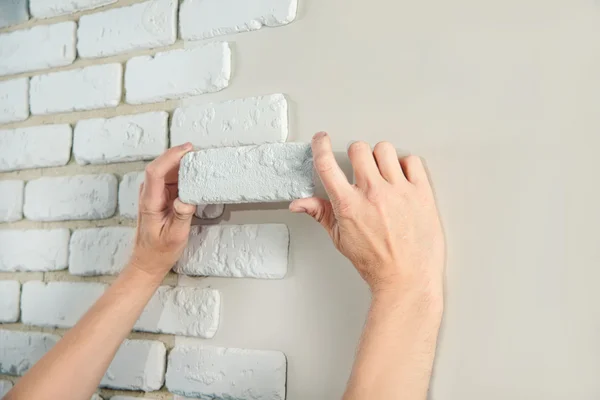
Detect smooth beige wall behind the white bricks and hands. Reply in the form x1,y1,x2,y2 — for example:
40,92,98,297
0,0,600,400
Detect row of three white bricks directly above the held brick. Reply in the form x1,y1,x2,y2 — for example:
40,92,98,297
0,94,288,172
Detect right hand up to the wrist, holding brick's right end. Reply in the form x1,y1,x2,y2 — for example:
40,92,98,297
290,132,445,300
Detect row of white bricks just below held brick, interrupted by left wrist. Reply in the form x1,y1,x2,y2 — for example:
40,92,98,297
0,224,290,279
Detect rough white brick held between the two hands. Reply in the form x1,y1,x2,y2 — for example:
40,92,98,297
179,143,314,204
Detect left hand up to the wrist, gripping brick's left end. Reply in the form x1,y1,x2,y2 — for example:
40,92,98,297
130,143,196,280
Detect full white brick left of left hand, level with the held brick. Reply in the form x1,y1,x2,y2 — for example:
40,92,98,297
23,174,117,221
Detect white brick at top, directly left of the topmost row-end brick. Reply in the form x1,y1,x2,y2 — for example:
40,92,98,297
77,0,177,58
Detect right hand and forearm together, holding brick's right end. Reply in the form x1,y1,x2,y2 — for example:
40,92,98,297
290,132,445,400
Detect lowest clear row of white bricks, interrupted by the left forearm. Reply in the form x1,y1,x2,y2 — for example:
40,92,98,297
0,330,287,400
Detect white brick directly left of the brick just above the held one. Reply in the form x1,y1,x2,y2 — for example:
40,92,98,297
73,111,169,164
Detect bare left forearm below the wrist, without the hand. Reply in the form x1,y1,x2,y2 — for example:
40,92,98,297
6,266,160,400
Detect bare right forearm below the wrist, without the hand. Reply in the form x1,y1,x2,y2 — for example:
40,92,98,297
343,291,442,400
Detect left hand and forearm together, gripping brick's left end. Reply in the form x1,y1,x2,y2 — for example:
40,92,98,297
4,143,196,400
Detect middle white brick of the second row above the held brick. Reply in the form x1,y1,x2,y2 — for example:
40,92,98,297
30,64,123,114
